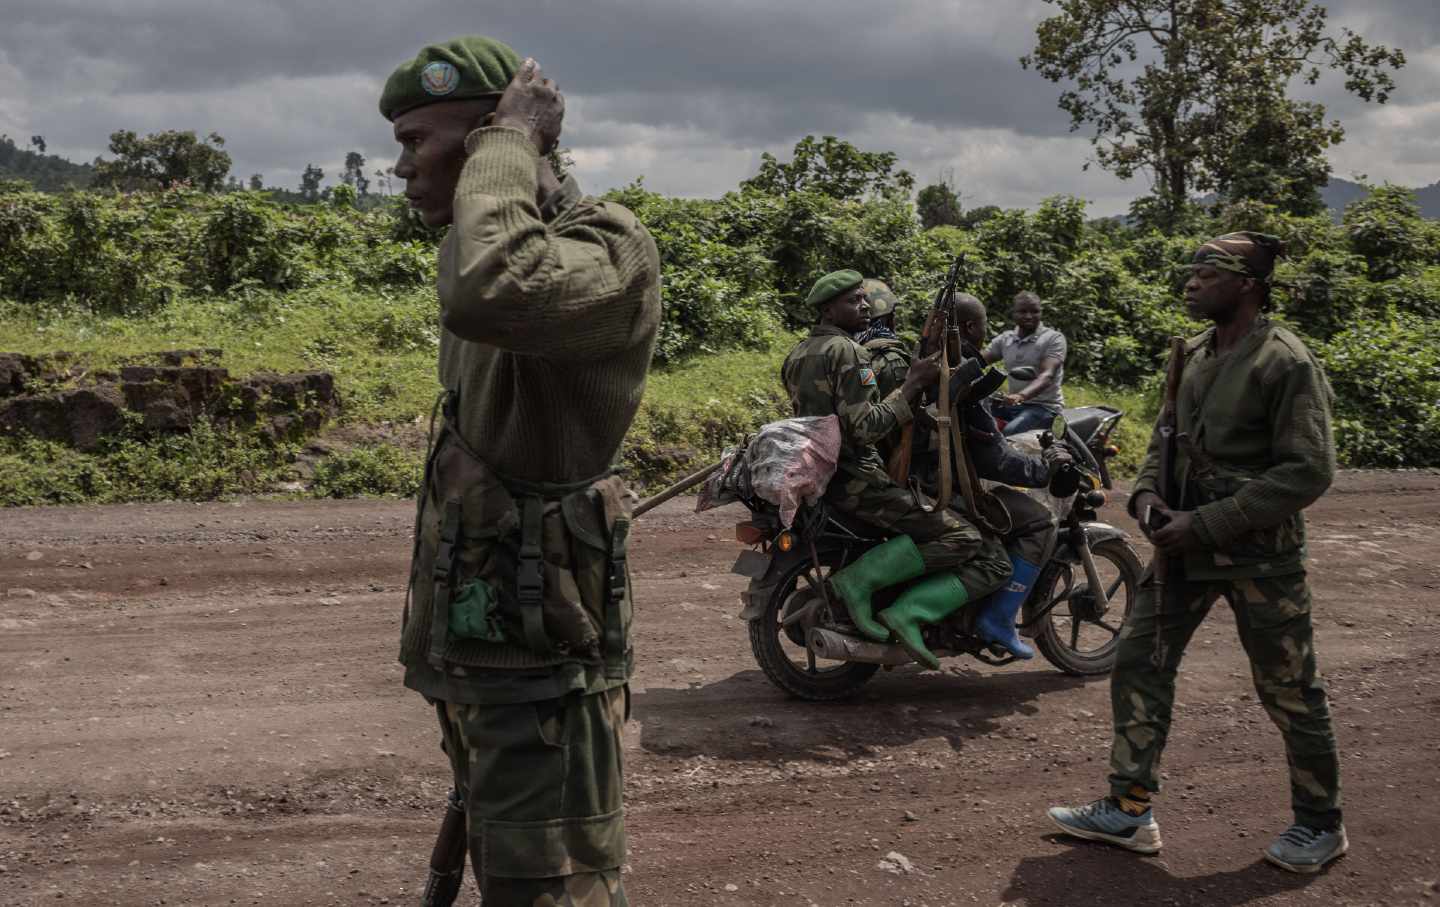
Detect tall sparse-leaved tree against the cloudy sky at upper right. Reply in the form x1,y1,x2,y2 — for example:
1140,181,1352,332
1021,0,1405,227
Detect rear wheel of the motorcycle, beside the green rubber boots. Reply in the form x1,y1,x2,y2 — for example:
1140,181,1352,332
750,553,880,701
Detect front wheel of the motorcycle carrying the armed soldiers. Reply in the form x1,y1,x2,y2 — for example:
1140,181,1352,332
1035,538,1142,677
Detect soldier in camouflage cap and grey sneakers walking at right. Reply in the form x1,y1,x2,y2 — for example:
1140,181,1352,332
1050,232,1349,872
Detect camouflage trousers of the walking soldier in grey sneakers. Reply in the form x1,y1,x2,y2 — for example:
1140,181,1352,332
1110,573,1341,828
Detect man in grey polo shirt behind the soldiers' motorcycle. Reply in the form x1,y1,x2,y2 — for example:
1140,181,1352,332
982,289,1066,435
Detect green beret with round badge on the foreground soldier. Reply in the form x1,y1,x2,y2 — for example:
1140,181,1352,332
380,35,521,119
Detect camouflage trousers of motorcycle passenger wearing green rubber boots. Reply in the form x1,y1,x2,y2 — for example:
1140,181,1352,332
825,472,1011,602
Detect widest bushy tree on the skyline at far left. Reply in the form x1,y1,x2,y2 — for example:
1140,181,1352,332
95,130,230,191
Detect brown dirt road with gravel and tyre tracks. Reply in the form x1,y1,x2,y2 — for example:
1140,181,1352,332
0,472,1440,907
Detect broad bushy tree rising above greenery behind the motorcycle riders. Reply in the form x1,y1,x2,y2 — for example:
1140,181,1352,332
740,135,914,199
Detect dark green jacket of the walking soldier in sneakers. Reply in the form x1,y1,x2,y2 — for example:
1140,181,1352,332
1130,318,1335,579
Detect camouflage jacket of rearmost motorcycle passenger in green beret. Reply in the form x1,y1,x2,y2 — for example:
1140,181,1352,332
780,324,914,484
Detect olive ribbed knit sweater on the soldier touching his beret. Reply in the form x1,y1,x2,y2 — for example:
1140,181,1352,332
439,127,660,482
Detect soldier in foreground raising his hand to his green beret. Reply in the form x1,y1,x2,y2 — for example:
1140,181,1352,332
380,37,660,907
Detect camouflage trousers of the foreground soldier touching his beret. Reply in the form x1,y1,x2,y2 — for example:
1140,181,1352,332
435,687,629,907
